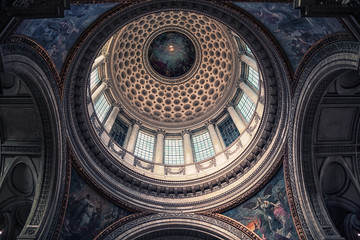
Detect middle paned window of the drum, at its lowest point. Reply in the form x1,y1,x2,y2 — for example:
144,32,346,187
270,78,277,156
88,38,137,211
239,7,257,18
164,139,184,165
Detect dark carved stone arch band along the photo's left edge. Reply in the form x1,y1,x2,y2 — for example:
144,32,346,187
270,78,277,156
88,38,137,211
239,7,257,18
1,39,66,239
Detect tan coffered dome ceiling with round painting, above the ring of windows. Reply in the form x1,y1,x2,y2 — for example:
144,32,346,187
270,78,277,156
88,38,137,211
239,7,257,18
106,11,239,128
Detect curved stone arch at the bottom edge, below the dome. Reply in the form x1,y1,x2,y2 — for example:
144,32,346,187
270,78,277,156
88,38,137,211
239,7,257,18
95,213,260,240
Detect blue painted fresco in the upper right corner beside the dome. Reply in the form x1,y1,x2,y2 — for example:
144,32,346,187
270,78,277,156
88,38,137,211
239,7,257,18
234,2,346,71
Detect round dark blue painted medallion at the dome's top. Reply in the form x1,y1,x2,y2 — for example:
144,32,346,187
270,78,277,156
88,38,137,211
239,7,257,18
143,26,201,85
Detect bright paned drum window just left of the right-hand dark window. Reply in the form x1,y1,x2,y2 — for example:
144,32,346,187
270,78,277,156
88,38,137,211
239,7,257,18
192,132,215,162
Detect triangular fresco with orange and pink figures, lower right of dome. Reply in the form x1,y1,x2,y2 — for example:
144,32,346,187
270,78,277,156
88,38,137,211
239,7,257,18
223,168,299,240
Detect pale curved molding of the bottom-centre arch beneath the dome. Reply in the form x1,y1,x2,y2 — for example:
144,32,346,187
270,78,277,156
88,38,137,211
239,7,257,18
95,212,261,240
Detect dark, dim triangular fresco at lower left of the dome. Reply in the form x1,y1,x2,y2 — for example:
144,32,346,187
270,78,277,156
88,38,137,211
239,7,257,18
60,169,131,240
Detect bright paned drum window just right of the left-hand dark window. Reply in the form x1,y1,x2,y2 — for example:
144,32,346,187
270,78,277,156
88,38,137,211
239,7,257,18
134,131,155,161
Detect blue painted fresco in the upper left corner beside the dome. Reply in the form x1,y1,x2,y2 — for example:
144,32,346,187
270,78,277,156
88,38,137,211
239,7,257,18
15,4,117,72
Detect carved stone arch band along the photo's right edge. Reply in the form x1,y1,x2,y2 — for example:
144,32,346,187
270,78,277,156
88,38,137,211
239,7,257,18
288,41,360,239
